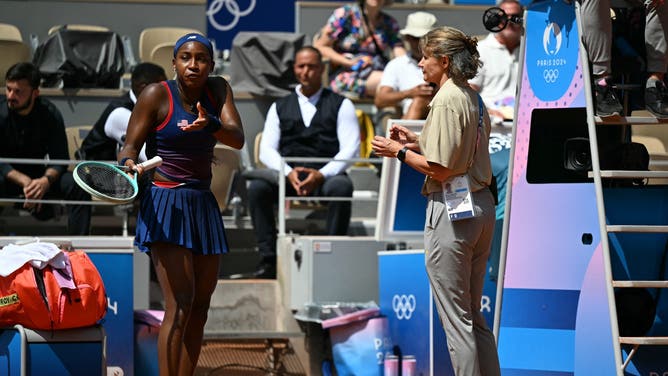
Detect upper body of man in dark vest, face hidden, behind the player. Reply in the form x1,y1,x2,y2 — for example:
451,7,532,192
77,63,167,161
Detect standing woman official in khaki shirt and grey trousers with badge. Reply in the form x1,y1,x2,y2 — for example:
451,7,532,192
372,27,501,376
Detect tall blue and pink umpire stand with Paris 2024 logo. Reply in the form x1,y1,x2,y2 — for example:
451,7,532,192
494,0,668,376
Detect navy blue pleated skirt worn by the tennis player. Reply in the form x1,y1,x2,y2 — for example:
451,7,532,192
134,185,229,255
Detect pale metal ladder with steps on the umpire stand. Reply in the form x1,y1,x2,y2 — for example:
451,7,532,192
576,3,668,368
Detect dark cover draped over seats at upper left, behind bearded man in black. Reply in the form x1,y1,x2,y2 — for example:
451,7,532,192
33,29,125,89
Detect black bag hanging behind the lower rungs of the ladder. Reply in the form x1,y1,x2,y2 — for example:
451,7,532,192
615,239,668,337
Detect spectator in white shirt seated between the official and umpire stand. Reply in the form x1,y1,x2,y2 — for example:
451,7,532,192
469,0,523,123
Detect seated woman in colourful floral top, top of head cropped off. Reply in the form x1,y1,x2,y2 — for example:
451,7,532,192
314,0,406,97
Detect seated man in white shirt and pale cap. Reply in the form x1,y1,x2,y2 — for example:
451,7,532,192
374,12,437,119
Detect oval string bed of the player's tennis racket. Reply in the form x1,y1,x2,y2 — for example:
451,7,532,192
76,165,135,199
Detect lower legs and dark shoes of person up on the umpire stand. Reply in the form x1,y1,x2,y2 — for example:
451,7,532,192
580,0,668,118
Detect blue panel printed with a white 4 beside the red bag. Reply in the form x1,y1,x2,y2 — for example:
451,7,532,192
87,249,134,376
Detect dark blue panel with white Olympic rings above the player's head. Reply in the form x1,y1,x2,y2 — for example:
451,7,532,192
206,0,295,50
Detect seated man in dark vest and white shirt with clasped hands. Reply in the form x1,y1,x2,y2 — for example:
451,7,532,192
248,46,360,278
